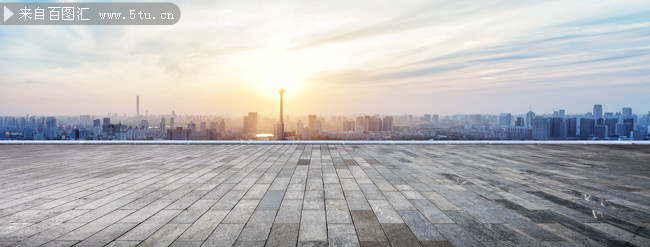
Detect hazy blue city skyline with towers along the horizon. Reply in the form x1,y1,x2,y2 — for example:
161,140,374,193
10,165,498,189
0,99,650,140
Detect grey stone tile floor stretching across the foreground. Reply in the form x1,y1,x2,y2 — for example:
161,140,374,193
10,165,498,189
0,145,650,246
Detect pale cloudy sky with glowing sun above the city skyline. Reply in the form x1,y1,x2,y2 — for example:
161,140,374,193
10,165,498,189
0,0,650,115
